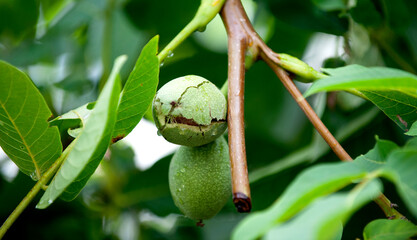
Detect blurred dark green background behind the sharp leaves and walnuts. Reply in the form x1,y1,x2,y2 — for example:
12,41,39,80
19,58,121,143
0,0,417,240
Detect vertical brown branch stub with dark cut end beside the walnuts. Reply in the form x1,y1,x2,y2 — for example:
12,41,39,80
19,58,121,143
221,1,252,212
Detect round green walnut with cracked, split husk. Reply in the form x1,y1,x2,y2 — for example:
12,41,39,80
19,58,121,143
153,75,227,147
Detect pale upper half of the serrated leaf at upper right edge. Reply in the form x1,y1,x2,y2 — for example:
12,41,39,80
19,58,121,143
304,65,417,97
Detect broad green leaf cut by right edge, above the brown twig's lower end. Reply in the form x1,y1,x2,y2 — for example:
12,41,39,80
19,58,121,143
382,148,417,217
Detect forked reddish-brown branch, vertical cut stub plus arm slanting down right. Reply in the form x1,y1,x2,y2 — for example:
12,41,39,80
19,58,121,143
221,0,405,219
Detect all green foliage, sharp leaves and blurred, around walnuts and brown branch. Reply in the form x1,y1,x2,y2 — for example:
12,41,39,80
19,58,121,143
0,0,417,240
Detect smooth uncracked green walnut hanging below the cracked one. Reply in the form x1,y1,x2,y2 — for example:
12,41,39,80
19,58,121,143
169,137,232,222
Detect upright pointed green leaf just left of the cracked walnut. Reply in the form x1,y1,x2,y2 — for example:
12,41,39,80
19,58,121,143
112,36,159,141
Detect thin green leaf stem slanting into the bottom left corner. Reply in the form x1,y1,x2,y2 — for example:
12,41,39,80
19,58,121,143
0,140,76,239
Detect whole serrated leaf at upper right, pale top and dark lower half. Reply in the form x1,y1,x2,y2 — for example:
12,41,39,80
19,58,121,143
305,65,417,131
